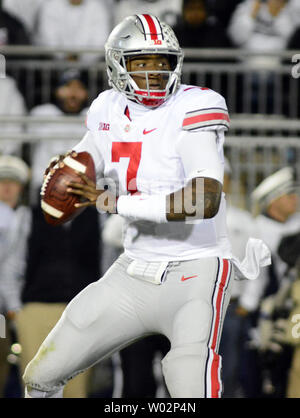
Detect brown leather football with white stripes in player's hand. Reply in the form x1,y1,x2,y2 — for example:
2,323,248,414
41,152,96,226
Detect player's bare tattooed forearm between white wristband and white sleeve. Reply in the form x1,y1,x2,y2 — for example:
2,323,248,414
167,177,222,221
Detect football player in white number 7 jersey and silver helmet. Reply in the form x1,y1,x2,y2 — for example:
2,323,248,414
23,14,268,398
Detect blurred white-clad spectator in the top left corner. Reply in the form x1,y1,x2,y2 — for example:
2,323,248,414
2,0,47,37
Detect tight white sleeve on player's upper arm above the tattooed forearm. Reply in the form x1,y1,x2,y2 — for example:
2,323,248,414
177,131,224,183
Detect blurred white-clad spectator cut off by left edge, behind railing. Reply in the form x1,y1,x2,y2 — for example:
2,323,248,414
0,76,26,155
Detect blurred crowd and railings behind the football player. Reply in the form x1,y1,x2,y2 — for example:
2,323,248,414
0,0,300,398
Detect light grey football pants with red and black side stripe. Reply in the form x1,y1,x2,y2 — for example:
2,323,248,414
23,254,233,398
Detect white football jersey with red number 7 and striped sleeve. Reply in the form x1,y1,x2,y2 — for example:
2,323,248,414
74,85,231,261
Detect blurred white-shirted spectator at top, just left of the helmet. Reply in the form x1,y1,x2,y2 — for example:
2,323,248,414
34,0,112,61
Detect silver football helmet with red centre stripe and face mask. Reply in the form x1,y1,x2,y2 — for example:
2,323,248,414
105,14,183,107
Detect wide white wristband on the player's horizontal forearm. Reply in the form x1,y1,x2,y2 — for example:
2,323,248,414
117,195,167,223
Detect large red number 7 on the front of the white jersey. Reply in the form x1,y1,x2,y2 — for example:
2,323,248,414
111,142,142,194
